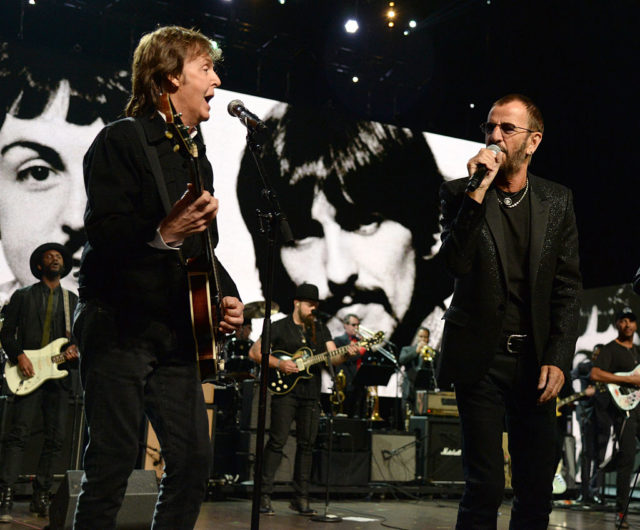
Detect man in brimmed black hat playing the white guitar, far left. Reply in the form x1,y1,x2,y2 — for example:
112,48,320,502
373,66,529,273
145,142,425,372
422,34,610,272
0,243,78,523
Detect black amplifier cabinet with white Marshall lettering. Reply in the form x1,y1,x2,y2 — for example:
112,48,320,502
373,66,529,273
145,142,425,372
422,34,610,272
409,416,464,484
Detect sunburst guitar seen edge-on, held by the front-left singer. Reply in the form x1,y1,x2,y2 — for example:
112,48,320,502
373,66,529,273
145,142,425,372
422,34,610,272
160,93,224,380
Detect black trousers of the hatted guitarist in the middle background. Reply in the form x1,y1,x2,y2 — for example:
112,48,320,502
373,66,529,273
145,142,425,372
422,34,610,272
262,389,320,497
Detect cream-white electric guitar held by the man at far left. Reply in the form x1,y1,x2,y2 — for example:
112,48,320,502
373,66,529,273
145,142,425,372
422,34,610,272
4,337,69,396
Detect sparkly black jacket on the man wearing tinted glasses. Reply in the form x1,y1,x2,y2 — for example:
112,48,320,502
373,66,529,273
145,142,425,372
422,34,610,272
438,174,581,387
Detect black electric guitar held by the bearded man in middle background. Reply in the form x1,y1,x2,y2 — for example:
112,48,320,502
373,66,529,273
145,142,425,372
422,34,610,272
268,331,384,395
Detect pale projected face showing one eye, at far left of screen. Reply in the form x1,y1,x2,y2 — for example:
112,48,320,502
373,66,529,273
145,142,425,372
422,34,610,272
0,81,104,287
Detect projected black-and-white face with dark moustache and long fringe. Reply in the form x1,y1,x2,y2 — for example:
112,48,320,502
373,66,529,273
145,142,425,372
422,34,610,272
238,105,450,340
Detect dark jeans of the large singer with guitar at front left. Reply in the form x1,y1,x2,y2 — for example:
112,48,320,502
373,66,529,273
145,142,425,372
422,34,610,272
74,302,212,530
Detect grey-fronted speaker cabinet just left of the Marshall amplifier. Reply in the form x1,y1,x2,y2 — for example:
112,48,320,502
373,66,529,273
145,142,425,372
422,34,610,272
371,433,416,482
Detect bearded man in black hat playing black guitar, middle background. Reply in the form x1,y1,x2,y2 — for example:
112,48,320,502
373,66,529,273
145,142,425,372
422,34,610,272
249,283,359,515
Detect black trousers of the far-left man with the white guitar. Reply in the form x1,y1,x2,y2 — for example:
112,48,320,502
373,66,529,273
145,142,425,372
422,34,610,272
0,380,69,491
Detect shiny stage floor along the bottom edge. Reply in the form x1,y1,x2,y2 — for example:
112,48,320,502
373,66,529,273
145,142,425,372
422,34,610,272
0,498,640,530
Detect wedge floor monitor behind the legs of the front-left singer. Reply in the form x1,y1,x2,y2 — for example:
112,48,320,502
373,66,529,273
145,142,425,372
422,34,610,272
49,469,158,530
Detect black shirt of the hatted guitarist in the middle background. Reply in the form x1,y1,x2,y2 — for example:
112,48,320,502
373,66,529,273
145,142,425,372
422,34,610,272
271,315,331,399
